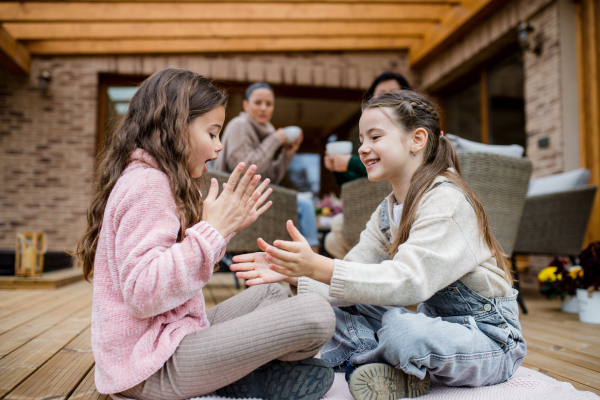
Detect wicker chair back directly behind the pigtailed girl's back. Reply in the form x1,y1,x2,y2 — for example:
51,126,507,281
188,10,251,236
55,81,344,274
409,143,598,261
458,153,532,257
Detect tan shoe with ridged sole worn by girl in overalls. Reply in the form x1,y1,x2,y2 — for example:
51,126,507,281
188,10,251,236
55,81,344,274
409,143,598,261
349,364,431,400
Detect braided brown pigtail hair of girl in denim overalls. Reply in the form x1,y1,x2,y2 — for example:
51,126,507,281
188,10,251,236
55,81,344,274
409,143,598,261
363,90,512,284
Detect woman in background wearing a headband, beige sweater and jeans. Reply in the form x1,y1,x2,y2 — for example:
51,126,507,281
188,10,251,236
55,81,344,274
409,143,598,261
214,82,319,252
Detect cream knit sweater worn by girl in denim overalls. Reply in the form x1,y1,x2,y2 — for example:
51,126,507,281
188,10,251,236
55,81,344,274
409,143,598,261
297,176,512,306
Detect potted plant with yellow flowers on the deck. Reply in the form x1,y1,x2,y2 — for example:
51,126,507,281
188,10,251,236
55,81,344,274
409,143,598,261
538,257,581,314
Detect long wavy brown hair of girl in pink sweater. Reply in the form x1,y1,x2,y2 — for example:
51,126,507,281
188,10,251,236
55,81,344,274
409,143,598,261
75,68,227,280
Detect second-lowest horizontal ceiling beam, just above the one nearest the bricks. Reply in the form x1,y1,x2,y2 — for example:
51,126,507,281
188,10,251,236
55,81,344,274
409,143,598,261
4,21,434,40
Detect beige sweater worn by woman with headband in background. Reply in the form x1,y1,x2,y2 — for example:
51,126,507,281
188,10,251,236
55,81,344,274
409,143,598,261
215,111,294,183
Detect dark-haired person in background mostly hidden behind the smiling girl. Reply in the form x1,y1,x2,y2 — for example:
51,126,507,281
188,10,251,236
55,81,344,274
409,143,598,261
323,71,411,259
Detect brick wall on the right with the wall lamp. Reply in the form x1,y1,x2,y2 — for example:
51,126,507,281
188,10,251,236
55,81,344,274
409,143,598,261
422,0,564,178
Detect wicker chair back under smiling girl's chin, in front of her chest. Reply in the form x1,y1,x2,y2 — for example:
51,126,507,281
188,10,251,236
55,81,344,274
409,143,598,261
342,178,392,247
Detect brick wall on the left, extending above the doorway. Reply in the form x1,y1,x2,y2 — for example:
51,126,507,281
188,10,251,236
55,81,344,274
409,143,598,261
0,52,412,251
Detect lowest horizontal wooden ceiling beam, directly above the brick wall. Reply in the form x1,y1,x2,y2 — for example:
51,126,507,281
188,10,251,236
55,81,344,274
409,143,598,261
25,37,420,55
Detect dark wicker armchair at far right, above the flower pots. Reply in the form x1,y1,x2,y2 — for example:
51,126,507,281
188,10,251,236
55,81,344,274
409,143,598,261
514,185,597,257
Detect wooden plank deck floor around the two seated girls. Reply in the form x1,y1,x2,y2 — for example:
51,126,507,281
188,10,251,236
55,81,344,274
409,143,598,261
0,273,600,400
